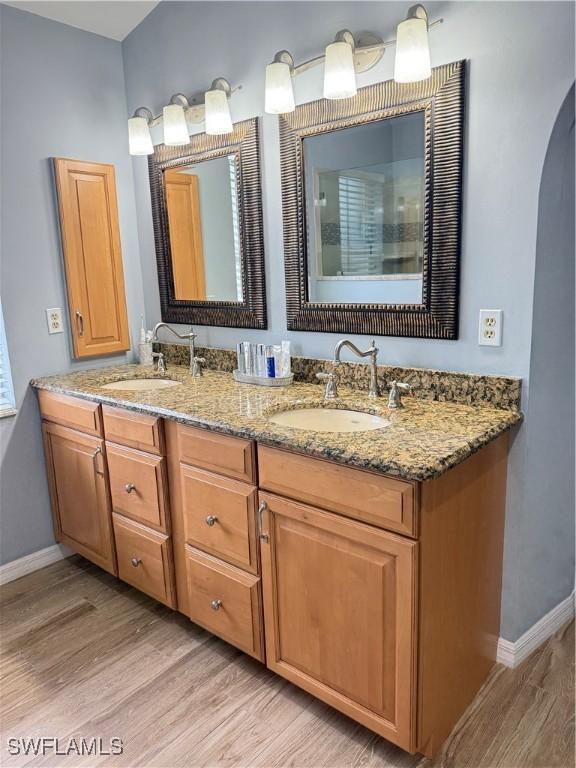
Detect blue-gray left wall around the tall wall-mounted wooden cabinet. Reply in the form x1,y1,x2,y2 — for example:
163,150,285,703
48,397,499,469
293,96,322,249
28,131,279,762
0,6,144,562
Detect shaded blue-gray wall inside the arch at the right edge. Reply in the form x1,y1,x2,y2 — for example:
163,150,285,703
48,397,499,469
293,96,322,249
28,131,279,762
503,87,575,637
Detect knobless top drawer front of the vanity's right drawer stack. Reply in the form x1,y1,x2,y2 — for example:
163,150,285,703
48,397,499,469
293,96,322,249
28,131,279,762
178,424,256,483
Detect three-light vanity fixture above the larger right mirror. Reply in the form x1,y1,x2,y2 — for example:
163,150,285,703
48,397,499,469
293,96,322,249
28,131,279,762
264,5,442,115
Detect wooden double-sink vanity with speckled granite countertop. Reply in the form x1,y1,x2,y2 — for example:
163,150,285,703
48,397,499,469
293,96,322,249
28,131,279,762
33,366,521,756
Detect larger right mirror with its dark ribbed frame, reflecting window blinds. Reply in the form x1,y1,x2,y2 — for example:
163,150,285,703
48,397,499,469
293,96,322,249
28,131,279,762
280,62,465,339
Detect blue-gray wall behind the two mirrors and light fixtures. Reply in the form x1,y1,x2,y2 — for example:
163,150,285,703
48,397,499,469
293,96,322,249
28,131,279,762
122,2,574,640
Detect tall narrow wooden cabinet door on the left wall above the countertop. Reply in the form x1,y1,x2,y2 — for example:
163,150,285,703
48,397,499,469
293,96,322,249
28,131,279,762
54,158,130,357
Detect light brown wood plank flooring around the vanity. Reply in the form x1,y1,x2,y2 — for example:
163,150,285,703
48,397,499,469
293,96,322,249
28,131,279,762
0,557,574,768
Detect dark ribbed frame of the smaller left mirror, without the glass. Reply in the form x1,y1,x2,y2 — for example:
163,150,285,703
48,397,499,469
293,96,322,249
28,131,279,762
148,118,267,328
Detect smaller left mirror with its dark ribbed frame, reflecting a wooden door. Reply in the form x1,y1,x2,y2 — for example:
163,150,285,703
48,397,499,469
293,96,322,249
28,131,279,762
148,119,266,328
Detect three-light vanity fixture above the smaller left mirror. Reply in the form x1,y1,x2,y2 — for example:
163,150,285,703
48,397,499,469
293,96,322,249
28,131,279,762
128,77,237,155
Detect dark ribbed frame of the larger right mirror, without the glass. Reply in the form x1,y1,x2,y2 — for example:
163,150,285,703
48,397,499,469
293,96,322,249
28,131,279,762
280,61,465,339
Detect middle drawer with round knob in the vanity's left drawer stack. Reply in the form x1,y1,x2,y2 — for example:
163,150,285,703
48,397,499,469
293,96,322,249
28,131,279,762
106,443,169,533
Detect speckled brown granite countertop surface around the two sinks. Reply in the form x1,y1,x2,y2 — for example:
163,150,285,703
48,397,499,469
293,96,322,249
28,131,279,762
31,365,522,480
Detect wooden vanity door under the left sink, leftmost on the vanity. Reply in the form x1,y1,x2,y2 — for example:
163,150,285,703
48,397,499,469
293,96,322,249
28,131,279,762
42,422,116,574
